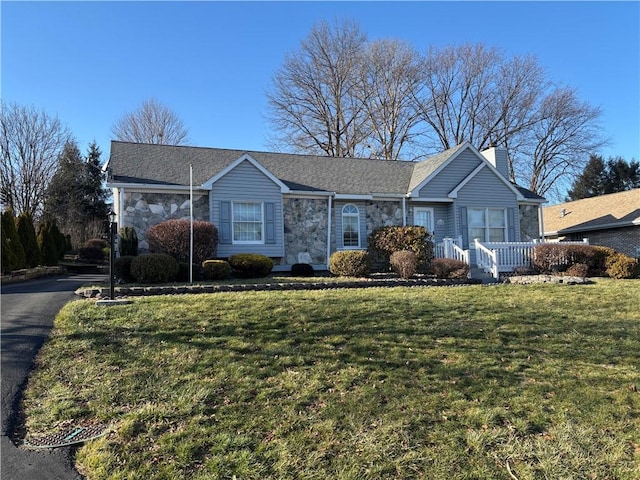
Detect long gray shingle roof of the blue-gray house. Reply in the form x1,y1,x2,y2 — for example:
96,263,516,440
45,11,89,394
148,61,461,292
109,141,541,198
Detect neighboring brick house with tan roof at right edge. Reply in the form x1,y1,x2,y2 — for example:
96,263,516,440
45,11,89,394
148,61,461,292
543,188,640,258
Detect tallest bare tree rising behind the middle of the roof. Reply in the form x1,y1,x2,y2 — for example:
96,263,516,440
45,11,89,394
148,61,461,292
267,21,369,157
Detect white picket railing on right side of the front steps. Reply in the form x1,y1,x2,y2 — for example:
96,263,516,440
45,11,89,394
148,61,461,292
475,238,589,278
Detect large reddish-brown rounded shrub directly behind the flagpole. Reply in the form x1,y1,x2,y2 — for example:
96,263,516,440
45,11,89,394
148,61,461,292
147,220,218,265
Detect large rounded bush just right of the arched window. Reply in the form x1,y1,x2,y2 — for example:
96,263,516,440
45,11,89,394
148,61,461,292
368,226,434,270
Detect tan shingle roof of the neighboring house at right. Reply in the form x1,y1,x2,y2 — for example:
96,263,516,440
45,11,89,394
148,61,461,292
543,188,640,235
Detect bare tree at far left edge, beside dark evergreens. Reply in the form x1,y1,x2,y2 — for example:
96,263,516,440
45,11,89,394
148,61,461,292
0,103,71,218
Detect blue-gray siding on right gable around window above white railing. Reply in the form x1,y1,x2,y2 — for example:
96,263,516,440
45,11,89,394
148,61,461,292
455,168,520,248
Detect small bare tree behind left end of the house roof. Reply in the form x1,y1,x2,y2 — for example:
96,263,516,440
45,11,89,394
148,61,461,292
111,98,189,145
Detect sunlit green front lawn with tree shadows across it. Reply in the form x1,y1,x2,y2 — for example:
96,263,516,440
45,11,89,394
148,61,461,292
24,280,640,480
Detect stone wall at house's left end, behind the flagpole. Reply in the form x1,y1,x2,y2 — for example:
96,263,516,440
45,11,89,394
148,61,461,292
120,190,210,253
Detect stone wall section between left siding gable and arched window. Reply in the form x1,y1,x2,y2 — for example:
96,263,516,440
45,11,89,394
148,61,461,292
281,198,329,265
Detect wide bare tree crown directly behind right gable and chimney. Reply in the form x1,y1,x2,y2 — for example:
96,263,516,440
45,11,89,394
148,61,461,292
416,44,545,156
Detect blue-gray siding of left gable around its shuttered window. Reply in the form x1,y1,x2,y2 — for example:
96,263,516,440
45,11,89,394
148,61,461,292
210,161,284,258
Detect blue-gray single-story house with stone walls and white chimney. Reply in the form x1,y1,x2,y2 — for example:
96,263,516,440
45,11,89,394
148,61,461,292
108,141,545,269
